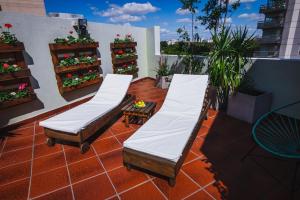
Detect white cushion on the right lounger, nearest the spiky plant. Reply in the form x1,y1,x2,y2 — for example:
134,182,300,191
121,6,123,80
124,74,208,162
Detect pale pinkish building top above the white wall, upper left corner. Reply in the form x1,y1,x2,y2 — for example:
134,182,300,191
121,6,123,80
0,0,46,16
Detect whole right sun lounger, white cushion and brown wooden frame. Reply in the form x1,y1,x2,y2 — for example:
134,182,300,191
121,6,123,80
123,74,210,185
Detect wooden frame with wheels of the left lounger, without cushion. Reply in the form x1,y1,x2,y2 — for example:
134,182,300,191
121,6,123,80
44,94,135,153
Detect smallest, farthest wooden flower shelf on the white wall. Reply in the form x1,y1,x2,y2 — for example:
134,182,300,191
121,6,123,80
110,42,139,78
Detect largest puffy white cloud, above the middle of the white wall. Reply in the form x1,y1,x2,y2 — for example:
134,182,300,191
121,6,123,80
90,2,159,23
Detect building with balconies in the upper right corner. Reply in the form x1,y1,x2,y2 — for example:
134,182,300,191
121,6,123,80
255,0,300,58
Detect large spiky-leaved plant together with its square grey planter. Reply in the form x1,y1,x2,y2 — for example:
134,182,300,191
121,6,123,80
208,26,271,123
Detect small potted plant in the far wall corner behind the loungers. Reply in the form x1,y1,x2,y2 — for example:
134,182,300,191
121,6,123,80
155,57,172,89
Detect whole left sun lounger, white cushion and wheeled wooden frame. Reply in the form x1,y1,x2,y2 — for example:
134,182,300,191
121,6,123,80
40,74,133,153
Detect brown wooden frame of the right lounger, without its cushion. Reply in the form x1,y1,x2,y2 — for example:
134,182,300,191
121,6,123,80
123,87,216,186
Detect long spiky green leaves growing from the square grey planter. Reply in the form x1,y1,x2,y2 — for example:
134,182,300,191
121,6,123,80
208,27,255,107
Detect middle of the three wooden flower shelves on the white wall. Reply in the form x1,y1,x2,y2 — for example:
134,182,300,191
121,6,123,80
49,42,102,95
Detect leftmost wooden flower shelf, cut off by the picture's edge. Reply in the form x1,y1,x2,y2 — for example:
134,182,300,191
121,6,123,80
0,42,36,109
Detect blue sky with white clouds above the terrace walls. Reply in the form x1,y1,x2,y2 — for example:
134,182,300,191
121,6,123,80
45,0,266,40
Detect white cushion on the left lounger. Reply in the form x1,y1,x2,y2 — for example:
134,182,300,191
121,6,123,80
40,74,132,134
